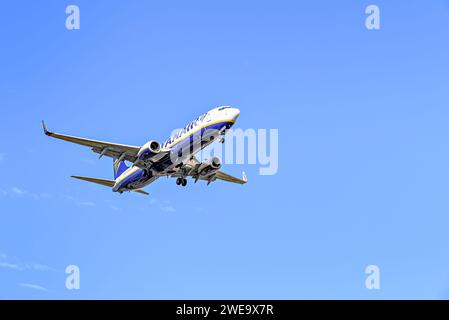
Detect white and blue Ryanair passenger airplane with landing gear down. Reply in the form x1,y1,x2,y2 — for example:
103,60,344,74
42,106,248,195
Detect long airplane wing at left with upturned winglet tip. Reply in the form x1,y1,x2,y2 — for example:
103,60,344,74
42,121,140,162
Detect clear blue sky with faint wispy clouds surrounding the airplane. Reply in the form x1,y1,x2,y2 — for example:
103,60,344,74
0,0,449,299
